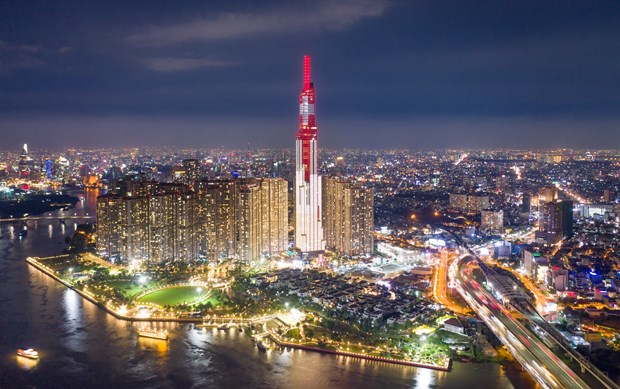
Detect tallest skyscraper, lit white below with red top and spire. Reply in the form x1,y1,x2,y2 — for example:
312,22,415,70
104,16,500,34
295,55,325,253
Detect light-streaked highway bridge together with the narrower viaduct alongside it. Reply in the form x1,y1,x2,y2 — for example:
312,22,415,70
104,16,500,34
450,237,619,389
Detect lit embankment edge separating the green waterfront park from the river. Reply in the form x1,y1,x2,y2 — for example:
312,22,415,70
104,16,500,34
26,255,451,372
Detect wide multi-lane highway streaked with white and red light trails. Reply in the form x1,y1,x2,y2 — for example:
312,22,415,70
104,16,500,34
450,255,589,388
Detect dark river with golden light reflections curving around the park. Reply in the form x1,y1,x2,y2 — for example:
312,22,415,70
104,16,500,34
0,190,536,389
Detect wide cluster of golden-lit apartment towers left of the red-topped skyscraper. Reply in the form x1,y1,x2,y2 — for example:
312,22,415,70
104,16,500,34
97,178,288,263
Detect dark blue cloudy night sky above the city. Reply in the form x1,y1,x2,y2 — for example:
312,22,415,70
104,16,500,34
0,0,620,149
